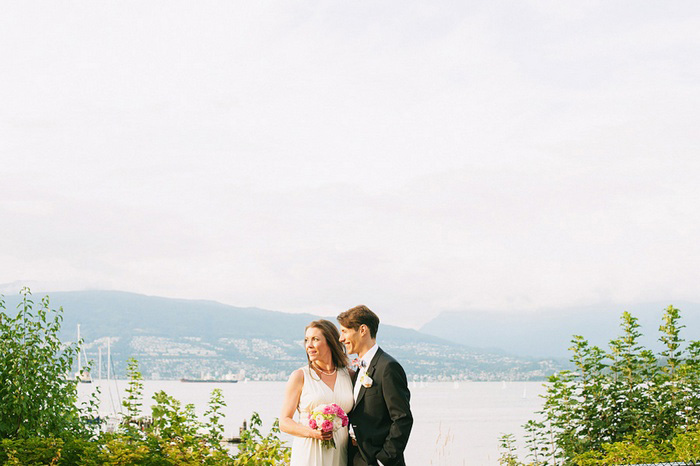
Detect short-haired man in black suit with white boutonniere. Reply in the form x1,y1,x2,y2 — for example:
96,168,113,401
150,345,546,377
338,306,413,466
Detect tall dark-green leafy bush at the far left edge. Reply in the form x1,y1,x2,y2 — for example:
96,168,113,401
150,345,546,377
0,288,89,439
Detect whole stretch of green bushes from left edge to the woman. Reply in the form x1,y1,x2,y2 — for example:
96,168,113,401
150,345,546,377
0,288,289,466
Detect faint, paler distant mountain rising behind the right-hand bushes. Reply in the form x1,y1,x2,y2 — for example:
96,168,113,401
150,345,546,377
420,301,700,359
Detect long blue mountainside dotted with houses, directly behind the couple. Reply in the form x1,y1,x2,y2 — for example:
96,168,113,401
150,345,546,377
5,291,558,380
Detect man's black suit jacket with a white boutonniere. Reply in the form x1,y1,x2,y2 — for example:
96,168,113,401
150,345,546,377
350,348,413,466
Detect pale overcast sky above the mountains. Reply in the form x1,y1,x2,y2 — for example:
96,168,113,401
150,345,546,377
0,0,700,326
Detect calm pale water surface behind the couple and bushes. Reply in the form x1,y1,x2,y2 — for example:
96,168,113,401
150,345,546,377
79,380,545,466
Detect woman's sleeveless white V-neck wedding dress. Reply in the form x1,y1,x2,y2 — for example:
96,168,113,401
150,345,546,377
289,366,354,466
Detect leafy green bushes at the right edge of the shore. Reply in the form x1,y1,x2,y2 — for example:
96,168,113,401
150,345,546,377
502,306,700,465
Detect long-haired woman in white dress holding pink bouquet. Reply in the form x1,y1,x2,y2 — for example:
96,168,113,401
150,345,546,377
280,320,354,466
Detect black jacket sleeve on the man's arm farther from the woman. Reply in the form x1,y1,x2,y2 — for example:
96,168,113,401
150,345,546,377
376,361,413,466
